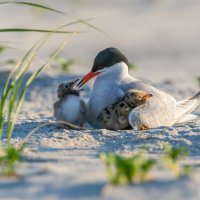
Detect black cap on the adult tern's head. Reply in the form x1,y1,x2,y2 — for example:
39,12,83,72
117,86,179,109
92,47,128,72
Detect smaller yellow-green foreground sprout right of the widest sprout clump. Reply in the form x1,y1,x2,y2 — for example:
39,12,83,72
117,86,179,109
162,145,191,177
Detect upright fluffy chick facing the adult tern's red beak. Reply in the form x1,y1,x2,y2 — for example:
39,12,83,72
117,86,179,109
53,79,86,127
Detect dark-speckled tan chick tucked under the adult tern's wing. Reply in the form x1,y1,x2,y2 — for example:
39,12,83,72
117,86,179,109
97,90,152,130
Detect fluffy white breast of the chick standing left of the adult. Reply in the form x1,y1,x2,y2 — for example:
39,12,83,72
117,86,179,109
60,95,80,123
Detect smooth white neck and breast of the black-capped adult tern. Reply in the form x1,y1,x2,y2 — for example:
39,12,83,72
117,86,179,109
89,62,128,119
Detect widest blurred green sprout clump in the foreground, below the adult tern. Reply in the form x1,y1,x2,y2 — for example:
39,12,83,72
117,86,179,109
101,153,156,185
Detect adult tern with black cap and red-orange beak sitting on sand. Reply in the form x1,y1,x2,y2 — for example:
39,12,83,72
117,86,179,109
77,47,200,128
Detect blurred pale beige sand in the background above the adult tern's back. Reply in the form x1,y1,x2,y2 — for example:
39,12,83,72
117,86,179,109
0,0,200,87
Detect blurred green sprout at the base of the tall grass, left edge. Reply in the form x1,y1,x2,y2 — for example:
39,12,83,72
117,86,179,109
0,145,24,176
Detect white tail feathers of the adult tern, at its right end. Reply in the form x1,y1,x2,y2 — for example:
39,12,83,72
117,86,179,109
175,92,200,123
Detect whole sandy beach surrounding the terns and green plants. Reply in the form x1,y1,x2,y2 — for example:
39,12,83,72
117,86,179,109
0,0,200,200
